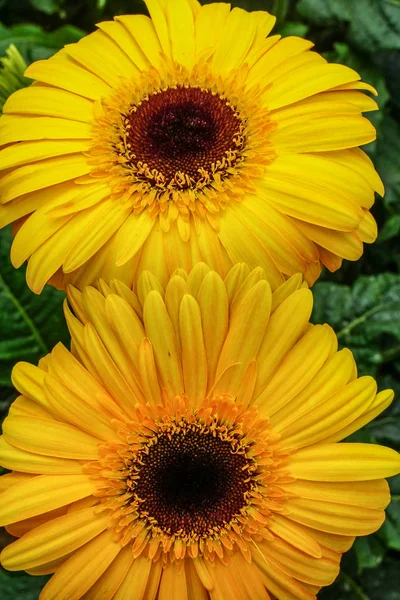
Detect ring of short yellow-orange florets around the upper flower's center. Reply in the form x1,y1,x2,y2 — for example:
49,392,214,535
87,61,275,223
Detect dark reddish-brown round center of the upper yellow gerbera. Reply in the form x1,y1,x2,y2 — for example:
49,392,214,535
123,85,244,189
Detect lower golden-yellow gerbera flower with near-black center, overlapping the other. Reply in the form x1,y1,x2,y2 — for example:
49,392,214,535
0,264,400,600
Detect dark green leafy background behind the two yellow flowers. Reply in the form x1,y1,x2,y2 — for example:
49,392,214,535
0,0,400,600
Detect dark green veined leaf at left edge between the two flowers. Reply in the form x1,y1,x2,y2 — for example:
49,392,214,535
0,229,69,386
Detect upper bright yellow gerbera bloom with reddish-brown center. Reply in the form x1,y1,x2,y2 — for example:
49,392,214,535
0,0,383,292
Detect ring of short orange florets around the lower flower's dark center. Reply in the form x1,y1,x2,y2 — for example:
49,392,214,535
86,396,287,561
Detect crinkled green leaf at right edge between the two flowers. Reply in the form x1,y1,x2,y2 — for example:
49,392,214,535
313,273,400,374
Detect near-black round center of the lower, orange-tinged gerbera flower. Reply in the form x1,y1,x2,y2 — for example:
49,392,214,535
129,424,254,537
